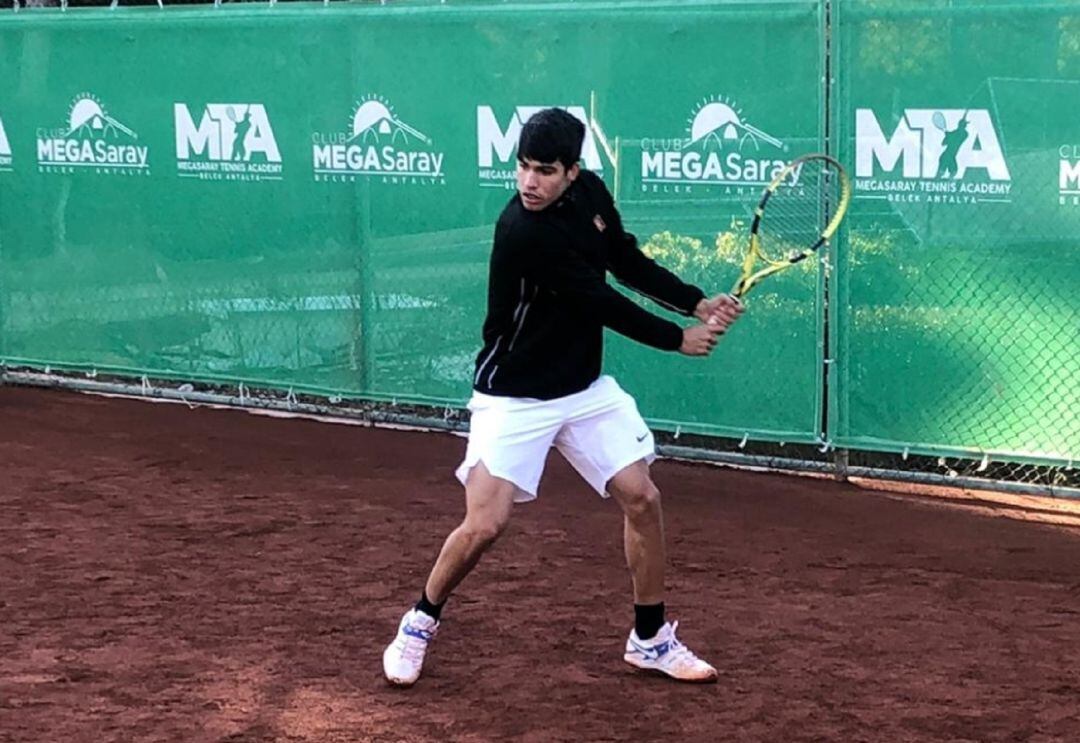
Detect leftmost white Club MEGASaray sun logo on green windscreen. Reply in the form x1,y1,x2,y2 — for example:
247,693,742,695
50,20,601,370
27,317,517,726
37,93,150,175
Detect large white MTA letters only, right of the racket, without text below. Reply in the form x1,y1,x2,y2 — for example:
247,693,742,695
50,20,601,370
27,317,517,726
855,108,1011,180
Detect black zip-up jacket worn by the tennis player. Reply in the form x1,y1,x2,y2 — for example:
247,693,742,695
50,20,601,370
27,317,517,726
473,170,705,400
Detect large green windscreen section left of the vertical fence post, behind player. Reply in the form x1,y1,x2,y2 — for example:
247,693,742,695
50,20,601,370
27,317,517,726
0,1,824,441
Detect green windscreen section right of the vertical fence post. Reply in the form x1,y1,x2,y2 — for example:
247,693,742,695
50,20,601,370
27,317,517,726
829,0,1080,462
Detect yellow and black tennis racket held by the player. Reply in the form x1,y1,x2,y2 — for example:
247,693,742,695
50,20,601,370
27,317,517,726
731,154,851,299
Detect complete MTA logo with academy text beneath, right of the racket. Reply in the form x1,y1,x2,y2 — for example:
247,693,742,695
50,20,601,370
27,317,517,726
855,108,1012,203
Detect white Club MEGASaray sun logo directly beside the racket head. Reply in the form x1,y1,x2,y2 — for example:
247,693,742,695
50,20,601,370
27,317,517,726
640,96,785,197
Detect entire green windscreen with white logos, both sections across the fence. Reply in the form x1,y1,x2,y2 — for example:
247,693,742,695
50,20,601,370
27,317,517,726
0,0,1080,465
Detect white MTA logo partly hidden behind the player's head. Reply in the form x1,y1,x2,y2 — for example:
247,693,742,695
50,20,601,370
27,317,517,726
476,106,604,189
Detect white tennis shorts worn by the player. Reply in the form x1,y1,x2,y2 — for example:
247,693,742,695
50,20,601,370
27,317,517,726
456,376,656,503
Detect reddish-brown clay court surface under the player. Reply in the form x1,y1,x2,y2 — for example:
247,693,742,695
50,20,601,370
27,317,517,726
0,388,1080,743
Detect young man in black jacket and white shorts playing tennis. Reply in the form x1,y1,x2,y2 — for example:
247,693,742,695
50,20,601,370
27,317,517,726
382,109,742,686
